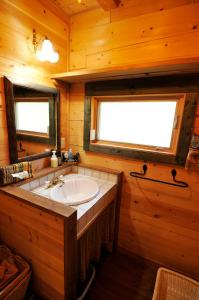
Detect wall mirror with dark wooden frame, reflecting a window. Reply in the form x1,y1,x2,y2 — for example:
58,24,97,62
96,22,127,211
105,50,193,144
4,77,60,163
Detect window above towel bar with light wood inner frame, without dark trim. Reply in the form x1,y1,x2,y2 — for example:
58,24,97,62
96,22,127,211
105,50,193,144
91,95,185,154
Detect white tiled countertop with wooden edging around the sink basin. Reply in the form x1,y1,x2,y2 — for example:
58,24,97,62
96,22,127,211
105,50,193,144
0,164,121,227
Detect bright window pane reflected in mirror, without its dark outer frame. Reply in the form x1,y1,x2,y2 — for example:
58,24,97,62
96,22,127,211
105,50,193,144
15,101,49,137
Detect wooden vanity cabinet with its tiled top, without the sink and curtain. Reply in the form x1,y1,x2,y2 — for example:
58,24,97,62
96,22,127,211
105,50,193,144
0,166,121,300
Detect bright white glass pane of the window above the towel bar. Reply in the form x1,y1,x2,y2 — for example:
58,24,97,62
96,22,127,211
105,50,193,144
97,100,177,148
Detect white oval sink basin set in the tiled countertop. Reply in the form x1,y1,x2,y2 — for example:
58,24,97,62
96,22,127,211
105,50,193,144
50,177,99,205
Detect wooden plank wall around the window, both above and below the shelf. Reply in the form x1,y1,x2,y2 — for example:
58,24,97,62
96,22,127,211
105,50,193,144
68,0,199,278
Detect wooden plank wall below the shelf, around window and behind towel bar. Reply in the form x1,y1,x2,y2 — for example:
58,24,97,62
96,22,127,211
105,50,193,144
69,84,199,277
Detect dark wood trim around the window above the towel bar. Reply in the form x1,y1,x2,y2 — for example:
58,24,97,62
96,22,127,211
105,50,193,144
84,74,199,165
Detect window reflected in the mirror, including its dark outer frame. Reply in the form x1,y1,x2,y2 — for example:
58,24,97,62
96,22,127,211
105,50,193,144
14,95,56,144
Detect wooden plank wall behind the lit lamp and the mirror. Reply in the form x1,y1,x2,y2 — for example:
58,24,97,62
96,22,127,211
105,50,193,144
0,0,69,165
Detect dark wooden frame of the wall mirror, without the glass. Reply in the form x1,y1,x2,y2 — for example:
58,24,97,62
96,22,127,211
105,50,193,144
4,77,61,164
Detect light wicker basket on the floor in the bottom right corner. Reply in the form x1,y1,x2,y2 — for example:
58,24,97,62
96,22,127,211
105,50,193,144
152,268,199,300
